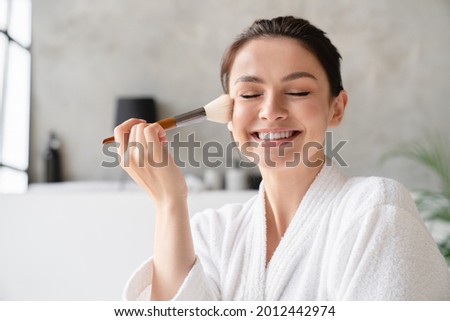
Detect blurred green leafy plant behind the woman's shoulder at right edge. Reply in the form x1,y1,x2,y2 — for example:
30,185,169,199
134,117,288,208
382,133,450,265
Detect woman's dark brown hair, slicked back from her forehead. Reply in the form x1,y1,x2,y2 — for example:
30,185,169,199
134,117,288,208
220,16,343,97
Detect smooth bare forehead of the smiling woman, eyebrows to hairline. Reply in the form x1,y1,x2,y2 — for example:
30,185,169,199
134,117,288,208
230,37,326,84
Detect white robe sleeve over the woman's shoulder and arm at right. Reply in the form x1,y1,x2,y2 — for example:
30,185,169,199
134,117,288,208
331,177,449,300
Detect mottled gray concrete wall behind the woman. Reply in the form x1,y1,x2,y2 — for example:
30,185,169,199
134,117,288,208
30,0,450,187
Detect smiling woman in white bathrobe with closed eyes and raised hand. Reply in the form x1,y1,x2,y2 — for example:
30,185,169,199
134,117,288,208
115,17,450,300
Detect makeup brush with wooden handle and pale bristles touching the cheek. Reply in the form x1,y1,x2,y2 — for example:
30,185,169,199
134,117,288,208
103,95,233,144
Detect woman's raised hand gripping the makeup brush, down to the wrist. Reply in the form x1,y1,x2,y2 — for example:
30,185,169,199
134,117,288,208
114,118,187,206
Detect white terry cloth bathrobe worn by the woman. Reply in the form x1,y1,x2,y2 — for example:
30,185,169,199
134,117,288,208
124,165,450,301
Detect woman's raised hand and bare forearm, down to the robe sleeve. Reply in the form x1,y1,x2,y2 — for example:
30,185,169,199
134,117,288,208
114,119,195,300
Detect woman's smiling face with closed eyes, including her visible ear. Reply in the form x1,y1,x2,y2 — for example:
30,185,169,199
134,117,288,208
229,38,347,168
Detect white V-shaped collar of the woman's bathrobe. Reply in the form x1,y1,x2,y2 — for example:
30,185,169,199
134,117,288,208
243,164,348,301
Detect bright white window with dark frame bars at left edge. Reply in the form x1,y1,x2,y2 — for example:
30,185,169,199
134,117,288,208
0,0,31,193
